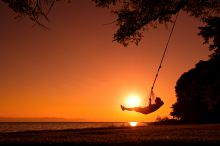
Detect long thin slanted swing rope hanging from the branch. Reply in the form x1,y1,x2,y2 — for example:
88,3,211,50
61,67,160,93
149,13,179,98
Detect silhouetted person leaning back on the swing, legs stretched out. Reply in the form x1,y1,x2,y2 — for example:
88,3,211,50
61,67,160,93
121,97,164,114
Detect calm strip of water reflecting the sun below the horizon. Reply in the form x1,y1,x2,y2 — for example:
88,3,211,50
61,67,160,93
0,122,147,133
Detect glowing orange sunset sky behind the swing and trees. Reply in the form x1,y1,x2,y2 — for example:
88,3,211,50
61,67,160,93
0,0,209,122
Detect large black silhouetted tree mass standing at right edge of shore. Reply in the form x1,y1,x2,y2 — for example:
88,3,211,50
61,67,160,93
171,17,220,123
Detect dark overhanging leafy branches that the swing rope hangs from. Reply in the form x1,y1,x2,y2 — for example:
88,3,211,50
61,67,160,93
93,0,220,46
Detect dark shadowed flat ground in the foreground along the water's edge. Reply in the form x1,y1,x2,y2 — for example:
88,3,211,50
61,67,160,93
0,124,220,146
